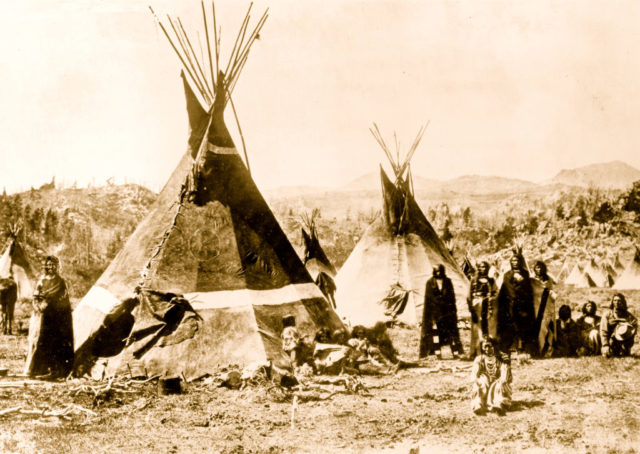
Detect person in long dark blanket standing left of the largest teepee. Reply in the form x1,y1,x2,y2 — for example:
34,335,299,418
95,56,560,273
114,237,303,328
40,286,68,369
25,255,73,378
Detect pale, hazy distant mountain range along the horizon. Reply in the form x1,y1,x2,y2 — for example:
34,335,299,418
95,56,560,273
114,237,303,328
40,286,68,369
266,161,640,197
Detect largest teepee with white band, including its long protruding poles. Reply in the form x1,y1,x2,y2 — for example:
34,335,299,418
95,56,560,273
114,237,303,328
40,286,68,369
73,4,343,379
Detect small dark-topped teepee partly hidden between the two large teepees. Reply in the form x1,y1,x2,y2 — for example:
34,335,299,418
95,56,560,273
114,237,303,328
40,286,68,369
302,208,336,308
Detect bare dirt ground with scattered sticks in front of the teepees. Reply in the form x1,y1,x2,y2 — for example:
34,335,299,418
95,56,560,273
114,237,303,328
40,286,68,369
0,290,640,454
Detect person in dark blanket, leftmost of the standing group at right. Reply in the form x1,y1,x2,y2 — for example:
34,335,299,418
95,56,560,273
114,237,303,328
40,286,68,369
419,265,463,358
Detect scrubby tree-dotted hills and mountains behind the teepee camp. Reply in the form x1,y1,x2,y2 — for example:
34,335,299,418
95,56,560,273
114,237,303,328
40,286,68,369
0,162,640,299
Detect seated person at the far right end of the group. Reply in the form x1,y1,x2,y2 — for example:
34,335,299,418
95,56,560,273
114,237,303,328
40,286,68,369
600,293,638,358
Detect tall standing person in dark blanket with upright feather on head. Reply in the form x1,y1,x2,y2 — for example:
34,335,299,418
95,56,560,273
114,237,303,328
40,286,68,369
497,252,538,356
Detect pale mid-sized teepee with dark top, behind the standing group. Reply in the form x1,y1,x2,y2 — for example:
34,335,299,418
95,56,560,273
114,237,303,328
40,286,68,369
336,125,469,325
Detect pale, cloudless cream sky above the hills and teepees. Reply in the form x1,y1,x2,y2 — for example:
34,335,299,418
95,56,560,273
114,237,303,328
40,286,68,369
0,0,640,192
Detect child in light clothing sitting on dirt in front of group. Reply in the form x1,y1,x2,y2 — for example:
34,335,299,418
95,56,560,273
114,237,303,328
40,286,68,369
471,338,513,415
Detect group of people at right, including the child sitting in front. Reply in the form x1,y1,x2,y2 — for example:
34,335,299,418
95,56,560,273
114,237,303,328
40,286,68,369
419,251,638,414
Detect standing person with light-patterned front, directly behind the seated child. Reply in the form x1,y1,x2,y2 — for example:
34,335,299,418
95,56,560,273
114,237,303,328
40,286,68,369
467,262,498,360
